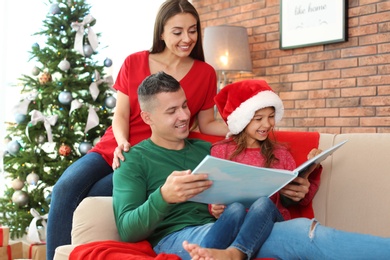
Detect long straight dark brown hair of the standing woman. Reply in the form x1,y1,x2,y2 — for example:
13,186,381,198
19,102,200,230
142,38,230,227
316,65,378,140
150,0,204,61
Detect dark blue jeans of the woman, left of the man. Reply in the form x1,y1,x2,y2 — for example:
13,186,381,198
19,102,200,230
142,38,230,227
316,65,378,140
46,153,113,260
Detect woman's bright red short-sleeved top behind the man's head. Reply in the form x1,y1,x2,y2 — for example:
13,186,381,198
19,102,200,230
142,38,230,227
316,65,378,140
90,51,217,165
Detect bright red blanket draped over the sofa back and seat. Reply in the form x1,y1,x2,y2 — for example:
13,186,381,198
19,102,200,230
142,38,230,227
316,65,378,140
69,131,321,260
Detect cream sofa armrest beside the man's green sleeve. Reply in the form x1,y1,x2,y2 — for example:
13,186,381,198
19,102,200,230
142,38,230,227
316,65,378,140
72,197,120,245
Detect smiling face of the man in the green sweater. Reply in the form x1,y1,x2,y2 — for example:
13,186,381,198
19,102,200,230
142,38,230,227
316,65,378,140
141,88,191,149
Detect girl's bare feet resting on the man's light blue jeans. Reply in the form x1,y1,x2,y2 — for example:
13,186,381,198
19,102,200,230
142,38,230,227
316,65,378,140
183,241,245,260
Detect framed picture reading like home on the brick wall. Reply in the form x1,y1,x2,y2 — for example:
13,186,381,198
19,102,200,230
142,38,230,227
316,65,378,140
280,0,348,49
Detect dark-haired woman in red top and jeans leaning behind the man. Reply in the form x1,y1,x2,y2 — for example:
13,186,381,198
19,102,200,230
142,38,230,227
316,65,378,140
47,0,227,260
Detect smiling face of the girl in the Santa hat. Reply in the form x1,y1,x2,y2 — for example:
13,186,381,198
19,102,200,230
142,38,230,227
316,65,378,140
244,107,275,148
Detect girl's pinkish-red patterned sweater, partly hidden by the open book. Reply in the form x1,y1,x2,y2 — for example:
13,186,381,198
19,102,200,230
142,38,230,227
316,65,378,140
211,142,320,220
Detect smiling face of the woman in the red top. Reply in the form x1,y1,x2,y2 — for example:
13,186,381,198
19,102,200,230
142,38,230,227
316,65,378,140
161,13,198,57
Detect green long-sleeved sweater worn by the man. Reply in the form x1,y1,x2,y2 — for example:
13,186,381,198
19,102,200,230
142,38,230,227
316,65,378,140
113,139,215,246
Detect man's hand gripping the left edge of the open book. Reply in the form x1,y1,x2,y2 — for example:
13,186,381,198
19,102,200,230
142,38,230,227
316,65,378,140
161,170,212,203
